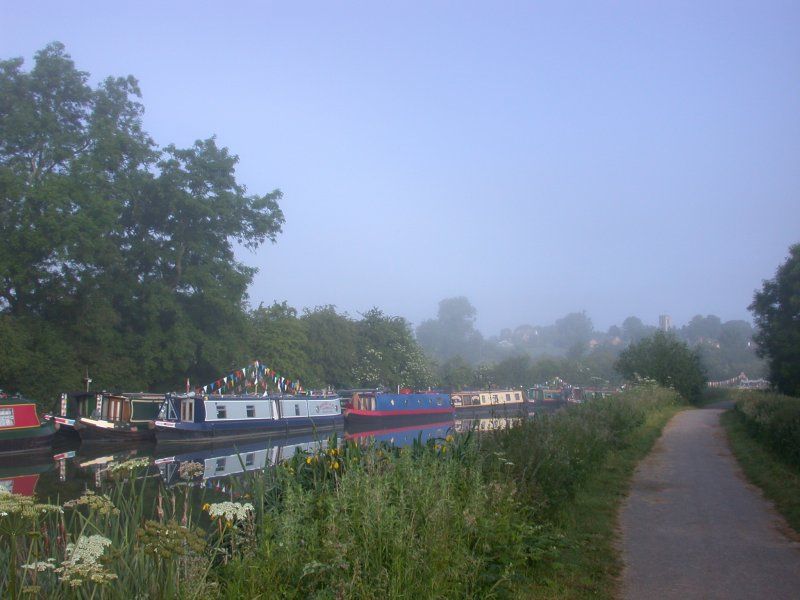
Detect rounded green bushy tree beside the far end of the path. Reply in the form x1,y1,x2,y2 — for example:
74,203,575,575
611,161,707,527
615,331,706,402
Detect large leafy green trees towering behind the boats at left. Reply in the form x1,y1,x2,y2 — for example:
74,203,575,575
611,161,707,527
0,43,283,395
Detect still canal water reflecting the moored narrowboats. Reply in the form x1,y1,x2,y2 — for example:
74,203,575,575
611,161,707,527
0,405,558,503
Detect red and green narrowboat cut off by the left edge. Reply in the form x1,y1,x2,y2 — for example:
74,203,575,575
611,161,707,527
0,393,55,454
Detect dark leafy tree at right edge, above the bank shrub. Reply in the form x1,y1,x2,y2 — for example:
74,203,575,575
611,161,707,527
749,244,800,396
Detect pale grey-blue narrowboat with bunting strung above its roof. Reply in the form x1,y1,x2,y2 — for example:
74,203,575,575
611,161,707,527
154,392,343,444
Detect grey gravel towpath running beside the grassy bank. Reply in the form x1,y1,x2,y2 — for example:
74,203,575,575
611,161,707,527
620,409,800,600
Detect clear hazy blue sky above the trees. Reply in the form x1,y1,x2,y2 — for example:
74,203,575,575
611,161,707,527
0,0,800,335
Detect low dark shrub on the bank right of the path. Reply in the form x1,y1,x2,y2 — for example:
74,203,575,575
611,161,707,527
735,391,800,467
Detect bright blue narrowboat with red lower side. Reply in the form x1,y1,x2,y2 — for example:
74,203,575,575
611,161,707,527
344,391,454,427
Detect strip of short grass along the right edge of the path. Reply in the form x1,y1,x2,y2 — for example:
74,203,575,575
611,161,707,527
721,410,800,533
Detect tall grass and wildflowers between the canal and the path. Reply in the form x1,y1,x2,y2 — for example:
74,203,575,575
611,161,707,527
0,387,677,598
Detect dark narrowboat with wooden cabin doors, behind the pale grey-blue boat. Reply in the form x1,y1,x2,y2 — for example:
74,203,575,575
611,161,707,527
77,392,164,444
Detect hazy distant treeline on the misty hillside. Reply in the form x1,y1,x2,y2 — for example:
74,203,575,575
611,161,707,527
416,296,767,383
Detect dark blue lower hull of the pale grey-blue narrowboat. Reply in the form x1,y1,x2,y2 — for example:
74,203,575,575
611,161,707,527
155,415,344,444
